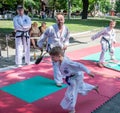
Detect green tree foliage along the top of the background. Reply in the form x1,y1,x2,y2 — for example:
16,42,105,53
0,0,116,19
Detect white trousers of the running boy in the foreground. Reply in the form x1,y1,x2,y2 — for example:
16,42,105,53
60,73,95,110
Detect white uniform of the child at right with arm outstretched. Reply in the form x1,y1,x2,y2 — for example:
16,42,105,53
91,27,116,63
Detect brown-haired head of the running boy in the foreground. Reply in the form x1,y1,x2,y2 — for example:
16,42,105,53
49,46,64,62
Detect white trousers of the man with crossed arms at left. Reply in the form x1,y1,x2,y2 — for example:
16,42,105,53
15,37,30,65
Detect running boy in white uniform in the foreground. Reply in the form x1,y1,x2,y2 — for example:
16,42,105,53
49,46,98,113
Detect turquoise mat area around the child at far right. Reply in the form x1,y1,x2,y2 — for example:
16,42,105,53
83,48,120,71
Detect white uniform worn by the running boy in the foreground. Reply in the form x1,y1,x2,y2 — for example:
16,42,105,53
59,57,95,110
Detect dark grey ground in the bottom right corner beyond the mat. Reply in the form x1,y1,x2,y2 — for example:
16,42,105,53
91,92,120,113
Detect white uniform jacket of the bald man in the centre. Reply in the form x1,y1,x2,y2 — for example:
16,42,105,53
38,24,70,51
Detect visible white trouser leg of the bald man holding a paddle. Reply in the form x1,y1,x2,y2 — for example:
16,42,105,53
53,62,63,84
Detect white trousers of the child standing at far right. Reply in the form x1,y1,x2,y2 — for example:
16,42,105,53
99,41,115,63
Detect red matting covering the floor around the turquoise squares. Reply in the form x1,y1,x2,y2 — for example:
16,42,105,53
0,46,120,113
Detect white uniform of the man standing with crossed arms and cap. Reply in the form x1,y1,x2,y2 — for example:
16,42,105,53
13,15,31,65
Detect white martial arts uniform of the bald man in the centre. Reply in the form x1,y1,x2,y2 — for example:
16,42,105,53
38,24,70,84
